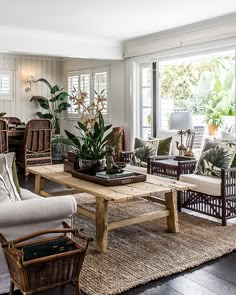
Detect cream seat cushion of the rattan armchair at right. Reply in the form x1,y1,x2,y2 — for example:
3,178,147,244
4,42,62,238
179,174,221,196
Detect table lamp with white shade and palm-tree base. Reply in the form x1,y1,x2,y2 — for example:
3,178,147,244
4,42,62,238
170,112,193,156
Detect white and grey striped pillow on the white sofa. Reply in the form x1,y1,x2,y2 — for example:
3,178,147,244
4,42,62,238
0,153,21,202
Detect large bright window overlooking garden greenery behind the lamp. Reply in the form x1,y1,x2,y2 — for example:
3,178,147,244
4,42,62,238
159,50,235,128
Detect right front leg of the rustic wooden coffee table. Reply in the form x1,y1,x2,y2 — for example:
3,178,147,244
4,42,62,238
165,192,179,233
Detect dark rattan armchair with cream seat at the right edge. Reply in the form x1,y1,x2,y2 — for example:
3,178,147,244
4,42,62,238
179,168,236,225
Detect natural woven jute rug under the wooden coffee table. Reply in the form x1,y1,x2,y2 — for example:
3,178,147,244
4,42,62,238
74,197,236,295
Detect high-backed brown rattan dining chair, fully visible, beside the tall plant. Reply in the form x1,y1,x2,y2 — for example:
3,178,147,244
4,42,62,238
18,119,53,174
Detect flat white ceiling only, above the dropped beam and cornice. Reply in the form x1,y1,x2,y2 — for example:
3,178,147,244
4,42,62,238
0,0,236,40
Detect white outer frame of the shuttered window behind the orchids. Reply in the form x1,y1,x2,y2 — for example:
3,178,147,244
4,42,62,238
67,66,111,121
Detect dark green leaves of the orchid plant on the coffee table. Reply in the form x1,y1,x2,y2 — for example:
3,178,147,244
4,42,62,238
52,112,120,160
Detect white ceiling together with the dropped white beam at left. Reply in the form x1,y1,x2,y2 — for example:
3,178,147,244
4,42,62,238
0,0,236,59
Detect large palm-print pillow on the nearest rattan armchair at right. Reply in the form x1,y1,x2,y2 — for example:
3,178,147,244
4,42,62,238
195,140,236,177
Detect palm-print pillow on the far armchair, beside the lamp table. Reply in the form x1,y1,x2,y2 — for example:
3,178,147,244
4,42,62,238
130,138,159,167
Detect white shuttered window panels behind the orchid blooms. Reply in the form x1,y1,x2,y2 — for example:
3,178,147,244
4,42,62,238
68,68,109,115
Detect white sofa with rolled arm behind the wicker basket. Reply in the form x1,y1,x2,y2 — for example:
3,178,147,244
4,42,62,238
0,189,77,294
